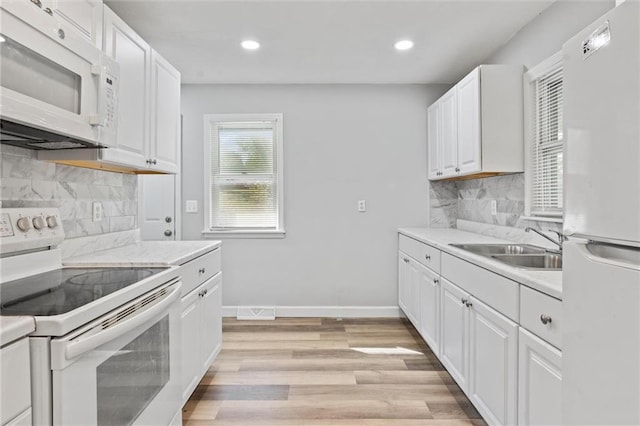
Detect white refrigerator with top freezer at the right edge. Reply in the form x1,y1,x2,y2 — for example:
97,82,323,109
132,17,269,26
562,0,640,425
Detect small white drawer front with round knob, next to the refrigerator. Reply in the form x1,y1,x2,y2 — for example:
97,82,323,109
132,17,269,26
520,286,562,349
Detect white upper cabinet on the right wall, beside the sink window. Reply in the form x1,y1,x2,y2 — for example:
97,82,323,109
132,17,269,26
427,65,524,180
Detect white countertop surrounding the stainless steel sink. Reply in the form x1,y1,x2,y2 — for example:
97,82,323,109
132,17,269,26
398,228,562,300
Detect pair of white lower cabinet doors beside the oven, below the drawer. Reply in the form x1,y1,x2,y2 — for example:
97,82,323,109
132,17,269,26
182,272,222,403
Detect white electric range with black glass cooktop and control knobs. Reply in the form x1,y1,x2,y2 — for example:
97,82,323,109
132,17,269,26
0,208,182,425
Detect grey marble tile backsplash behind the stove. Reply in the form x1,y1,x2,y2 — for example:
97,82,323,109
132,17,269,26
0,145,138,238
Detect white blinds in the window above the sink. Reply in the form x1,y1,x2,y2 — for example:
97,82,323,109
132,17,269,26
530,66,563,216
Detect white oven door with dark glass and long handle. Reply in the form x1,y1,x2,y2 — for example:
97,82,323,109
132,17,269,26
51,280,181,426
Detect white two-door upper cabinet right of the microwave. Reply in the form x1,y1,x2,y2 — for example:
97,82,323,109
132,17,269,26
102,6,181,173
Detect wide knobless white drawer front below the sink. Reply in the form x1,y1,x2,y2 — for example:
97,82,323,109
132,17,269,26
440,253,520,322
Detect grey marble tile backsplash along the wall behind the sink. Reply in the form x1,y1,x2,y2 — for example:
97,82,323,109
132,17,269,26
429,173,562,230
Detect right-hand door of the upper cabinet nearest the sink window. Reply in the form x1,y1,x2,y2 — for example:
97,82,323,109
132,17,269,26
456,68,482,175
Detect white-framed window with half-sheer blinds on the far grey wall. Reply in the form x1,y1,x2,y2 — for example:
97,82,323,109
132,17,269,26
203,114,284,236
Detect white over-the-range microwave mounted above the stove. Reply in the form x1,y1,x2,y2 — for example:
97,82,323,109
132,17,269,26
0,1,119,150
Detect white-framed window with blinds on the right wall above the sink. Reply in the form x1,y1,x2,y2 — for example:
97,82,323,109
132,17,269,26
525,53,564,221
